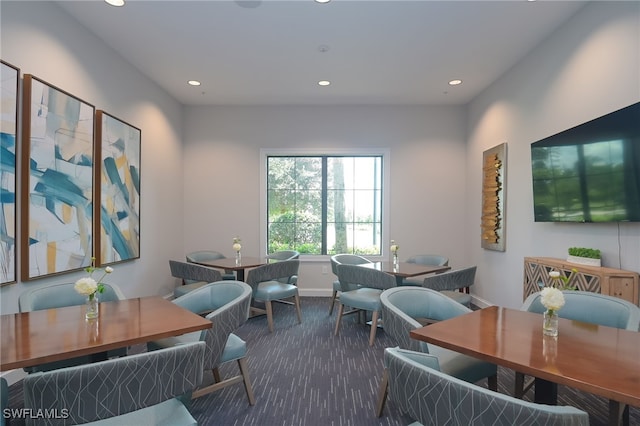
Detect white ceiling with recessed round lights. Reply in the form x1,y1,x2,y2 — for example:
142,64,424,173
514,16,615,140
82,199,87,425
58,0,585,105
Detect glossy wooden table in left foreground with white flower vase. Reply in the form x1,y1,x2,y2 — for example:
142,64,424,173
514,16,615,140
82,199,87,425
0,297,212,371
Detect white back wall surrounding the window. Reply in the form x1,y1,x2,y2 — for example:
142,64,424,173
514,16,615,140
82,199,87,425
184,106,466,295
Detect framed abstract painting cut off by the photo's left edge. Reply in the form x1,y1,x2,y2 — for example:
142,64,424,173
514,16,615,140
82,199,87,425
0,61,20,285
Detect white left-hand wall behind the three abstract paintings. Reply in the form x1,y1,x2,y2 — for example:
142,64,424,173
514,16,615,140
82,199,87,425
0,2,183,314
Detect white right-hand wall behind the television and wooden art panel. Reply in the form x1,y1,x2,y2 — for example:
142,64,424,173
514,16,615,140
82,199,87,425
466,2,640,307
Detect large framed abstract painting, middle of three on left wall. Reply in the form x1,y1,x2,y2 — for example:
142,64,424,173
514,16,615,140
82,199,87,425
20,74,95,280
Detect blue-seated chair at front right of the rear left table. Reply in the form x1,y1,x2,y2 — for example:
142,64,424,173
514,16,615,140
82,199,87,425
247,259,302,333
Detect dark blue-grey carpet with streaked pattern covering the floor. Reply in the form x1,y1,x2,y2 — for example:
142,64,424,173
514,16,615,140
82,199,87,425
10,298,640,426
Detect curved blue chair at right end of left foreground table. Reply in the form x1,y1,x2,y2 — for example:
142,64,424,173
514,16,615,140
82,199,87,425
147,280,255,405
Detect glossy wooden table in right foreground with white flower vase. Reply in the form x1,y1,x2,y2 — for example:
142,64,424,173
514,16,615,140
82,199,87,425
410,306,640,425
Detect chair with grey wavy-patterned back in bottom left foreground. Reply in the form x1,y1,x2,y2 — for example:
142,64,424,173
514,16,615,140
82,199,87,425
24,342,205,426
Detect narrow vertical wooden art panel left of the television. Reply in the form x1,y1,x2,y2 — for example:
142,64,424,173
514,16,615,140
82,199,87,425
480,143,507,251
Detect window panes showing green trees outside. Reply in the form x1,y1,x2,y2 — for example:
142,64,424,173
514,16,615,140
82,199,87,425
267,156,382,255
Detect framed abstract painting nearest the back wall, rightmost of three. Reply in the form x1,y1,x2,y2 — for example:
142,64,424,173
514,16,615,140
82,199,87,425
94,110,141,265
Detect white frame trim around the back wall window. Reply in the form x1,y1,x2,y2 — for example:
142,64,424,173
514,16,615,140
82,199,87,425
260,148,391,262
